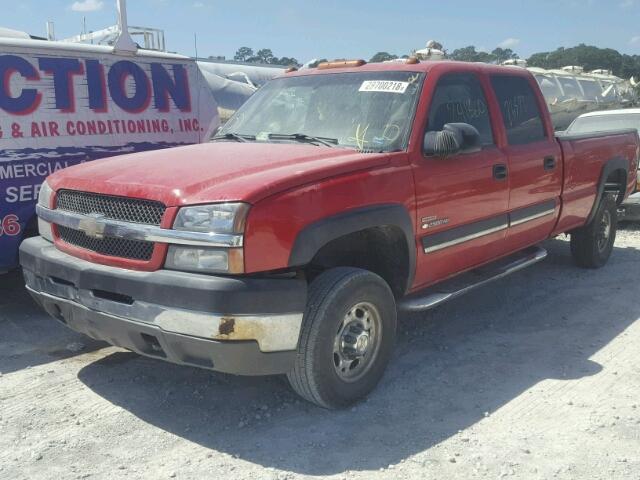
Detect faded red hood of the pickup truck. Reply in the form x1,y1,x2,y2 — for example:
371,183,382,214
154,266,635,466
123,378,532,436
47,142,389,206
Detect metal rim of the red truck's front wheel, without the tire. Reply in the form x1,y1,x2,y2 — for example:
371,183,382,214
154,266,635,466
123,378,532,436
333,302,382,382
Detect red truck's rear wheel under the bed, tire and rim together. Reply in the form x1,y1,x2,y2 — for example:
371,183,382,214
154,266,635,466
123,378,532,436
571,195,618,268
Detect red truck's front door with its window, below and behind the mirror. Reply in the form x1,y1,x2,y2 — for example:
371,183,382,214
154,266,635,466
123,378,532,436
412,71,509,286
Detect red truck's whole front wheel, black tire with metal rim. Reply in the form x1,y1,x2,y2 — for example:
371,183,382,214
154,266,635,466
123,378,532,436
287,267,397,409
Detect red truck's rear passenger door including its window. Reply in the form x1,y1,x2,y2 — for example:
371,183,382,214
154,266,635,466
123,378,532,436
491,74,563,251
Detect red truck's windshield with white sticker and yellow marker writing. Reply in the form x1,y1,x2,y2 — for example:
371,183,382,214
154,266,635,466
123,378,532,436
214,71,424,152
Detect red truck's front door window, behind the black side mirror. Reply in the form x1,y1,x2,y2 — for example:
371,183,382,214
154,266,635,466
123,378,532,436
427,73,493,146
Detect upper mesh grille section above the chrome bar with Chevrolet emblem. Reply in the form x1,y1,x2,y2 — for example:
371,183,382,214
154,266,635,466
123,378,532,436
56,190,165,225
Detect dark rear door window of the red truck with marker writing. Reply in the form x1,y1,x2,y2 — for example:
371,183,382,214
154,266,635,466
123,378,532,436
491,75,546,145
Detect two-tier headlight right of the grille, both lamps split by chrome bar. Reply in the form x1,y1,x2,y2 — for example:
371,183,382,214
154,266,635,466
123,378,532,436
165,203,249,273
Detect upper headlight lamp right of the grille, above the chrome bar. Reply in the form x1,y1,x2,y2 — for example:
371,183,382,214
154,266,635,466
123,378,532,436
173,203,249,233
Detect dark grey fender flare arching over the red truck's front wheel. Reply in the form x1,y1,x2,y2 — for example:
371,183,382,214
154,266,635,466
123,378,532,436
289,204,416,291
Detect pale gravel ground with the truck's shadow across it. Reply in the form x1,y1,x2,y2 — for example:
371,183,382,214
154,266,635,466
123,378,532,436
0,229,640,480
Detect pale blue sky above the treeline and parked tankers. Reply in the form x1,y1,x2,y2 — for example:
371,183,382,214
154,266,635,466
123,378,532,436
0,0,640,62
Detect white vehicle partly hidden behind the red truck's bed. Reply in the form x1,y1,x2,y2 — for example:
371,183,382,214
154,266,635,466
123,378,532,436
566,108,640,222
